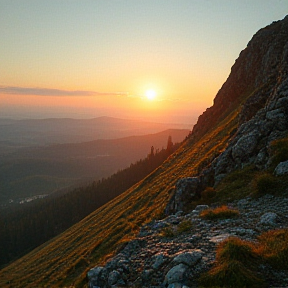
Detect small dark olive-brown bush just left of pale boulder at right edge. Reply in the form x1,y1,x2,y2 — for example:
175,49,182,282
254,173,278,196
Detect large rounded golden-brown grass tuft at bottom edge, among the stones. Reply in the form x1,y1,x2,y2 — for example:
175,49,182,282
200,237,264,288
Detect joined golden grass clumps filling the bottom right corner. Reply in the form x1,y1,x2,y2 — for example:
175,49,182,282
200,229,288,288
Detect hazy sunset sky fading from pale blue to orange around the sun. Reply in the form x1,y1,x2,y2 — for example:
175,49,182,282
0,0,288,123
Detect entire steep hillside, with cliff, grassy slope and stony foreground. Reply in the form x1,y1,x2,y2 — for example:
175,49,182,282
0,16,288,288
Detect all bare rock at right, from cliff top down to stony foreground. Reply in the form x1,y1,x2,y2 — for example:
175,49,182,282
87,16,288,288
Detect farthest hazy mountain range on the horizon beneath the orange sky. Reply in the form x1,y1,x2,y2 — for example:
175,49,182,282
0,117,192,154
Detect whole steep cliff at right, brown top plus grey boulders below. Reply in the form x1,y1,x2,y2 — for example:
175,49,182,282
192,16,288,186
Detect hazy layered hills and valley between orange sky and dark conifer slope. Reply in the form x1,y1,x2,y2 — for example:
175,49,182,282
0,117,189,208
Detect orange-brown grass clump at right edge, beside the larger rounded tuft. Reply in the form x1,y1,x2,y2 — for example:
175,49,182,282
258,229,288,269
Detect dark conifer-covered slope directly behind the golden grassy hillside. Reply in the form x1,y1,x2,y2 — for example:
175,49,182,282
0,137,179,267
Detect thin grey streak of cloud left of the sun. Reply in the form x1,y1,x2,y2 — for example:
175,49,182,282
0,86,128,97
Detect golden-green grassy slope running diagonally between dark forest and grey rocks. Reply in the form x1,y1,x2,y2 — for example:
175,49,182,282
0,110,238,288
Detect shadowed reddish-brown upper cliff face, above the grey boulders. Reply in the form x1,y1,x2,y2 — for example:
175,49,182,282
193,16,288,140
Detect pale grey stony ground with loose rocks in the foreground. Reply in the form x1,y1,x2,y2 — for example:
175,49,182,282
87,195,288,288
